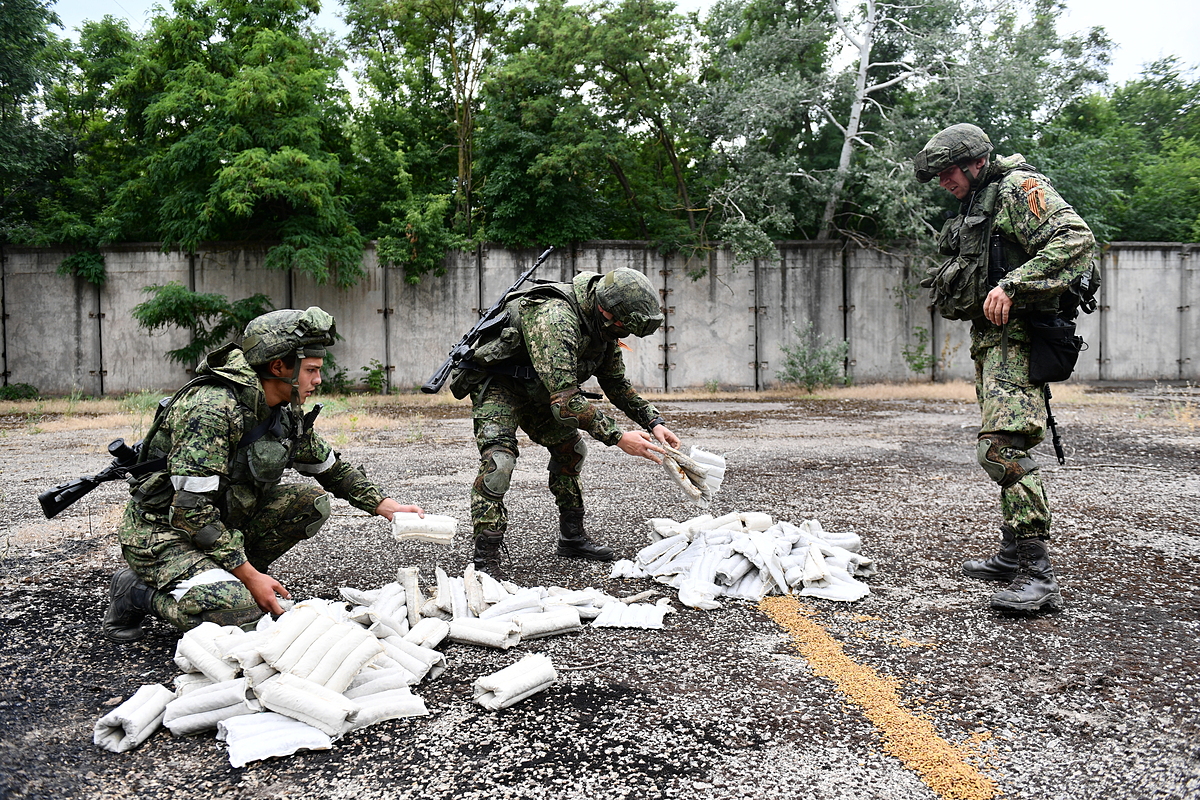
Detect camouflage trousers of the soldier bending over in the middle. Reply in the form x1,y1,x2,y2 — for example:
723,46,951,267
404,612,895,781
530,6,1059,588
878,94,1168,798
470,379,583,535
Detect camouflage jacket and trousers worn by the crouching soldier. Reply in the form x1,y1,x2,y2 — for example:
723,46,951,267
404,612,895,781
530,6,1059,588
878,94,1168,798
119,345,386,630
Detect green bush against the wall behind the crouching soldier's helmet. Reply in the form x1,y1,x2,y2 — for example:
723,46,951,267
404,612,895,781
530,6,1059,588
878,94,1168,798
133,281,272,365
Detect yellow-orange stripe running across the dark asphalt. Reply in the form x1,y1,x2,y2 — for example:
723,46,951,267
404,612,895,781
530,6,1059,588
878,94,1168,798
758,596,1000,800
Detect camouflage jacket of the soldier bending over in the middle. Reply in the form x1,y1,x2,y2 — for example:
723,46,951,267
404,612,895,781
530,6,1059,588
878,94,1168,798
460,272,659,445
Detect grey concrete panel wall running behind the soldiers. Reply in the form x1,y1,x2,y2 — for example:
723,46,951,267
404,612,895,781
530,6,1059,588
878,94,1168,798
0,241,1200,395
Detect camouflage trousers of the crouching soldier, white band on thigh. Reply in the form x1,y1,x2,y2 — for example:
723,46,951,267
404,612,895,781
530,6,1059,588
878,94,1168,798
118,483,328,631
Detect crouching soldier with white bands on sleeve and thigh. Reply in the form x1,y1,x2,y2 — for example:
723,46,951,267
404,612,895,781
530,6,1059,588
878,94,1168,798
103,306,424,642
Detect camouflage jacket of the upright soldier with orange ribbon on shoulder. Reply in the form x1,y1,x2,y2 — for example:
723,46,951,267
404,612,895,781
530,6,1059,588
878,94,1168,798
940,155,1096,347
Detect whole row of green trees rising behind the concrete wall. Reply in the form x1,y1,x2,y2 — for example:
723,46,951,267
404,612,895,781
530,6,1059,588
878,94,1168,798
9,0,1200,263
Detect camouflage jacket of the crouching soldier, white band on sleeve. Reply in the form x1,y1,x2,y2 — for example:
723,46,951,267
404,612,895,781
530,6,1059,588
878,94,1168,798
130,345,386,570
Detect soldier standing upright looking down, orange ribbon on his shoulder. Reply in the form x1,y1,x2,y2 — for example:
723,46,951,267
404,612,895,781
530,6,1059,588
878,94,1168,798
913,124,1096,612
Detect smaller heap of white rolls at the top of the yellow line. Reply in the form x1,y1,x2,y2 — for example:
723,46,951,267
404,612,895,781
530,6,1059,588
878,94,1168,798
611,512,875,610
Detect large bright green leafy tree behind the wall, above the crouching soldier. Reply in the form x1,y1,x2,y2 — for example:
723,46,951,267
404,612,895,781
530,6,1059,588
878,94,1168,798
109,0,365,285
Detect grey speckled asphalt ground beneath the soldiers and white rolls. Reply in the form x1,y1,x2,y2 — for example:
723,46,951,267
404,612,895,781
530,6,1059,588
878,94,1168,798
0,385,1200,800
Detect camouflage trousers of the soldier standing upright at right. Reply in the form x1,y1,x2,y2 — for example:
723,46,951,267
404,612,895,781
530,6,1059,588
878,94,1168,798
971,341,1050,539
